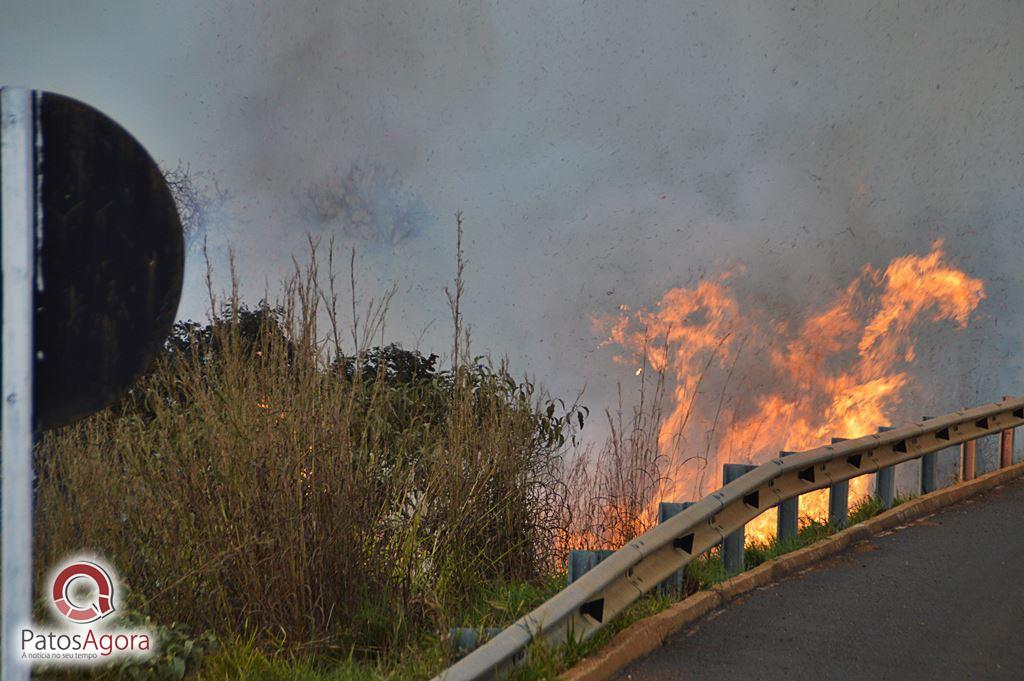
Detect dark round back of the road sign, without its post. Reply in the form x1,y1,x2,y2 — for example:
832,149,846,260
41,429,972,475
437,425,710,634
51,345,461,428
1,91,184,429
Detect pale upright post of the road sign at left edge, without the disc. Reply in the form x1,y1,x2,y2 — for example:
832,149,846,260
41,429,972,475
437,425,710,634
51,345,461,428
0,88,37,681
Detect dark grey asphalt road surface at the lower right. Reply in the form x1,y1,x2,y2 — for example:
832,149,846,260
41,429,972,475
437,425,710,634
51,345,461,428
618,480,1024,681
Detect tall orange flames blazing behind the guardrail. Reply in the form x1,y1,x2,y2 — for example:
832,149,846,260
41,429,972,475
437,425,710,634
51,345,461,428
595,241,985,539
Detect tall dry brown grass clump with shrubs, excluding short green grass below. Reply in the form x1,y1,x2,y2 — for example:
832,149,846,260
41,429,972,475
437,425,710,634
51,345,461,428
36,236,580,656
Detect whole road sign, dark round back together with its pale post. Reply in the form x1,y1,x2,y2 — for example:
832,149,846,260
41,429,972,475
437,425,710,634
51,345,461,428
0,88,184,681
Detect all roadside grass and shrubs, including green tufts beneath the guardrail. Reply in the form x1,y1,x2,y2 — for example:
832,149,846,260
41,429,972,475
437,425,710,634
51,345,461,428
35,208,921,680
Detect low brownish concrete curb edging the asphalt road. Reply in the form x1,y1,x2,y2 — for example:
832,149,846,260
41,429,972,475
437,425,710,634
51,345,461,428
560,456,1024,681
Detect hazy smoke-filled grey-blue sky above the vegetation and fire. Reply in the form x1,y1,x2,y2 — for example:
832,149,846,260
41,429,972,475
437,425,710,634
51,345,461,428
0,0,1024,419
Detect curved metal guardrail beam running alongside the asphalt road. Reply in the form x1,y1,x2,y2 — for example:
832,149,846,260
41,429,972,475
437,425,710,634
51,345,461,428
434,397,1024,681
